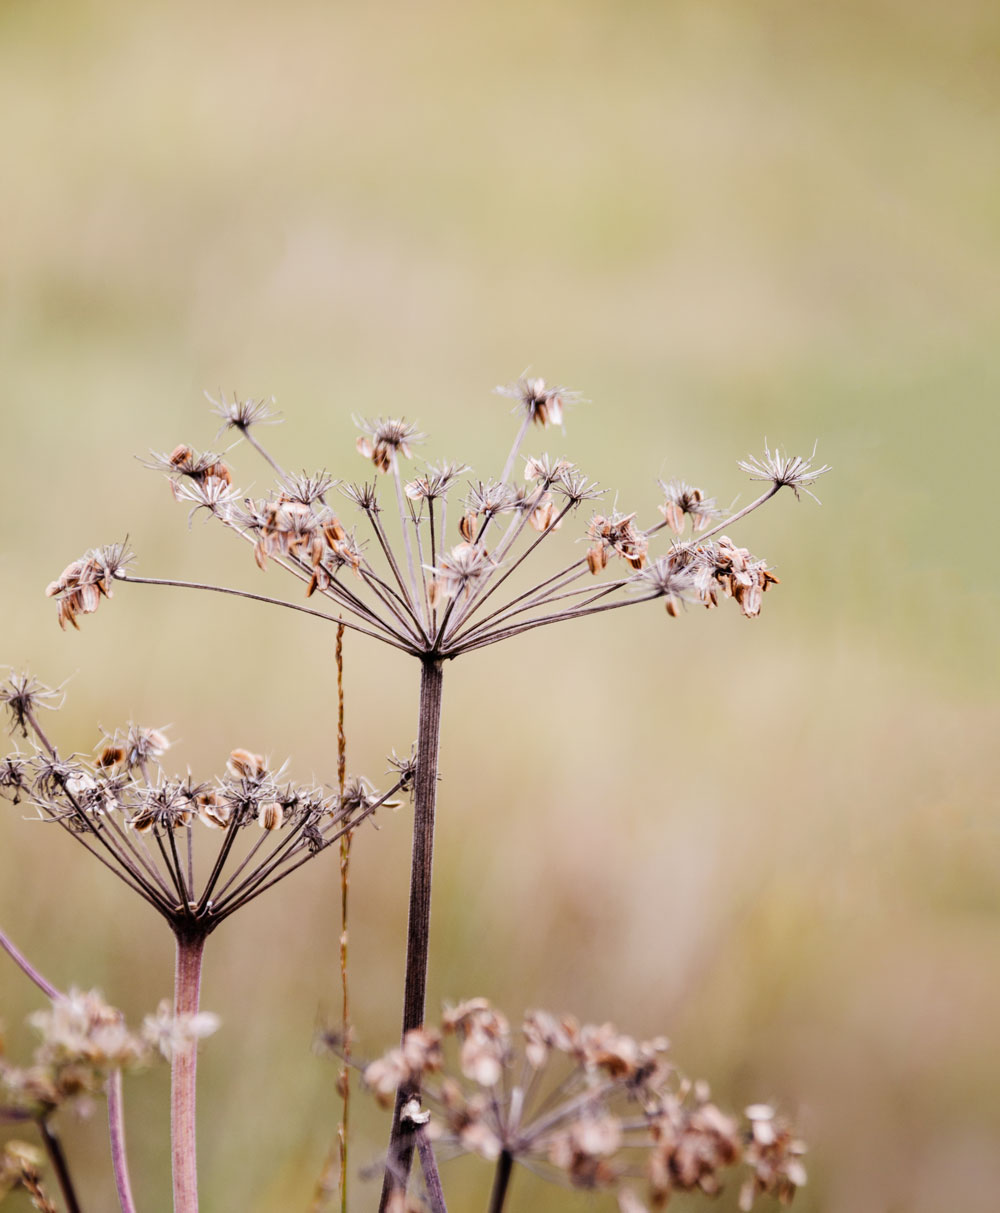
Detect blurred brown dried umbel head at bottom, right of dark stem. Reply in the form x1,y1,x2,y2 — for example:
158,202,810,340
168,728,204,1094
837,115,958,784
351,998,806,1213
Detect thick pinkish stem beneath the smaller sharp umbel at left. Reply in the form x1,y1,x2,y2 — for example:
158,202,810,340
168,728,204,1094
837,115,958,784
170,927,205,1213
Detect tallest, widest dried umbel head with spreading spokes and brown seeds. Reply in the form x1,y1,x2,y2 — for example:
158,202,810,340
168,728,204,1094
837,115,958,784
50,377,829,660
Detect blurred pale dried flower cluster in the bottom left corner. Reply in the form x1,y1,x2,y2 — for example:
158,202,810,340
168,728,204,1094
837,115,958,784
0,990,207,1118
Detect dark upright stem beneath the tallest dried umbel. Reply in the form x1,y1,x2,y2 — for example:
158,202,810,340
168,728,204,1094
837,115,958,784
379,657,443,1213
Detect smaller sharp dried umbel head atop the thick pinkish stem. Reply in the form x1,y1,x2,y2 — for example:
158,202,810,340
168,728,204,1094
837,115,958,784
0,677,411,932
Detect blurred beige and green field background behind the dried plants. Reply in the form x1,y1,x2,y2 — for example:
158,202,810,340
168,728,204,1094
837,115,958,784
0,0,1000,1213
